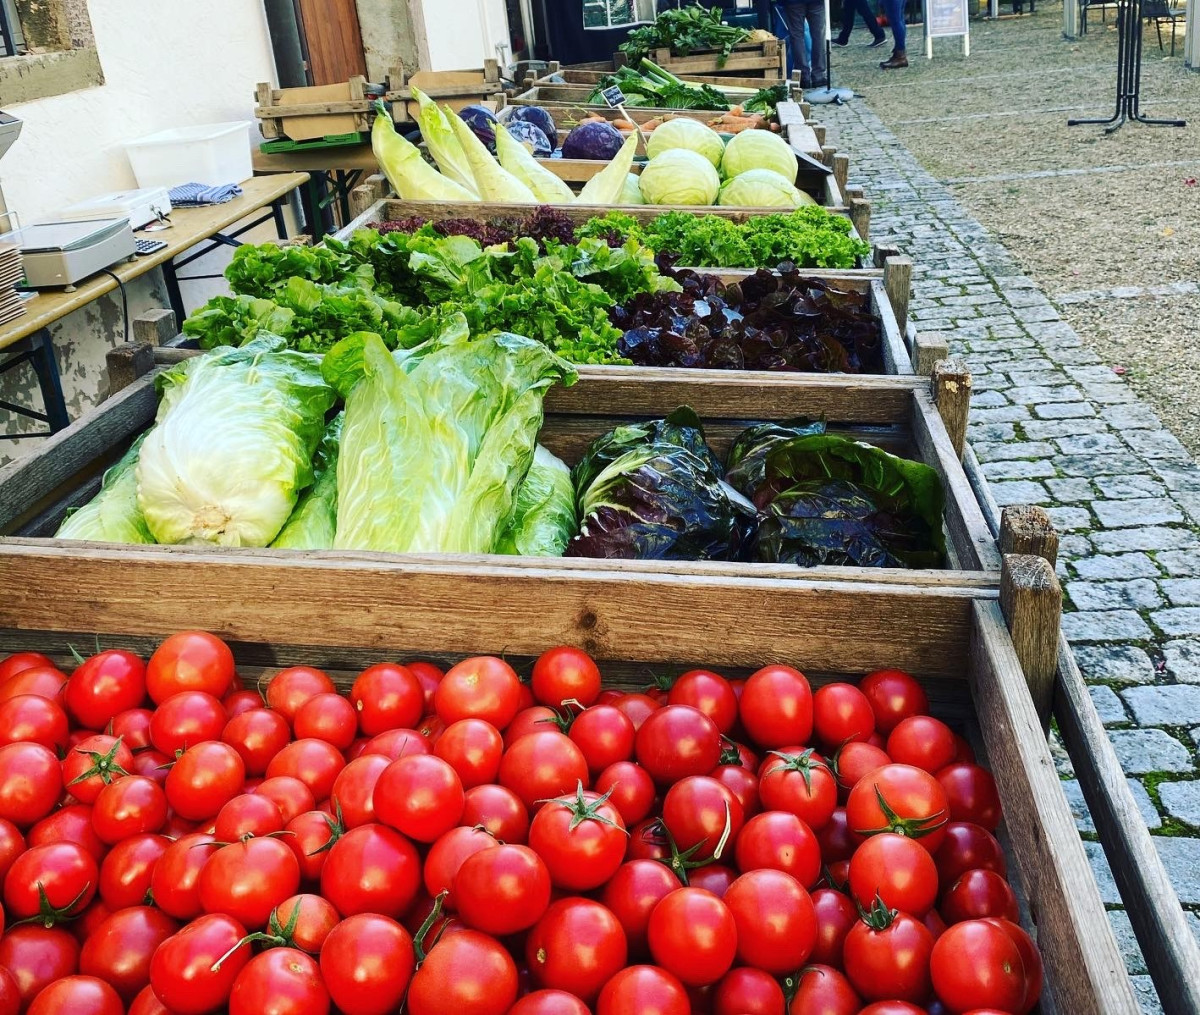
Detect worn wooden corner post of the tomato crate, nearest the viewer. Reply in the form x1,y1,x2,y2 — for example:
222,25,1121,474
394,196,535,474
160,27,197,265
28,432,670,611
1000,553,1062,726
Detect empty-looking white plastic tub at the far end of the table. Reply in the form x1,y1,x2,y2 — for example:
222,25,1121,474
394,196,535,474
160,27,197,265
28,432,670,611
125,120,254,188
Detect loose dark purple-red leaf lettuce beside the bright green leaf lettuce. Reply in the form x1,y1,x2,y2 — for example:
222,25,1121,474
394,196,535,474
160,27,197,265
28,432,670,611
610,266,883,373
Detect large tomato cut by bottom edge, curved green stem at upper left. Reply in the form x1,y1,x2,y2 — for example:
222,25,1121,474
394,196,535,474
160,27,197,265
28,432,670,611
406,931,517,1015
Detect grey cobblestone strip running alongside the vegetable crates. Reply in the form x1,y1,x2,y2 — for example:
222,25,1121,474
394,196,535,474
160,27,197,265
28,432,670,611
815,100,1200,1011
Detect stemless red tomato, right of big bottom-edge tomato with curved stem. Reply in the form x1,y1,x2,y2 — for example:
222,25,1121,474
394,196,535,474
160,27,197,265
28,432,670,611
526,897,628,1003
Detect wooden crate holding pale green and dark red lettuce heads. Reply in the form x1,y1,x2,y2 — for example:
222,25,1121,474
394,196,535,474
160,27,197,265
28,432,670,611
0,364,1000,585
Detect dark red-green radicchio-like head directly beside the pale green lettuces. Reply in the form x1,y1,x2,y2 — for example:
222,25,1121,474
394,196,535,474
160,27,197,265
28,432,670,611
566,409,755,560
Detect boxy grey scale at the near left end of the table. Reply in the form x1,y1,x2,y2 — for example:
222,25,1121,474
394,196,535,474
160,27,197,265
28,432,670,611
10,218,136,290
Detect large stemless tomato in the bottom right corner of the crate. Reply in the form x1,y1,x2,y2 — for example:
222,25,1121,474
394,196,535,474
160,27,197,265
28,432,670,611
930,920,1025,1011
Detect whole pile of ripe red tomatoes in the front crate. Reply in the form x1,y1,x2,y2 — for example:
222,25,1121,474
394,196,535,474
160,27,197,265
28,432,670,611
0,631,1042,1015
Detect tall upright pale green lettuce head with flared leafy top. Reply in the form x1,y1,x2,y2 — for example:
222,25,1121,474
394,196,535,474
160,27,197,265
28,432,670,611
323,316,575,553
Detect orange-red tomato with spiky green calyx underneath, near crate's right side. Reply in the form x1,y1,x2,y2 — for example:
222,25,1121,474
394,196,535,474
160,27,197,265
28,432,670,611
846,764,949,853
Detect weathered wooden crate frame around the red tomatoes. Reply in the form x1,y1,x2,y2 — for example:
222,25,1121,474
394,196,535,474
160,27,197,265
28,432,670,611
0,540,1139,1015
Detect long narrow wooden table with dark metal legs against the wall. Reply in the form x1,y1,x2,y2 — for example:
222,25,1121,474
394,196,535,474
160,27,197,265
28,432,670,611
0,173,308,440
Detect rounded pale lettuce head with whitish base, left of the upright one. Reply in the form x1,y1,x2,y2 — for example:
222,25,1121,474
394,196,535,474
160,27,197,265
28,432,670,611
137,335,334,546
